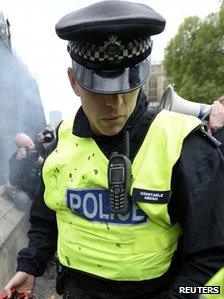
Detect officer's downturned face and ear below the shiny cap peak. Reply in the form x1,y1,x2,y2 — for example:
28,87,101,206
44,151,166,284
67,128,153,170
68,69,139,136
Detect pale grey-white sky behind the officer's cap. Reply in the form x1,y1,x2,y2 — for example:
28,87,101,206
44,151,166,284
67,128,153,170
0,0,220,117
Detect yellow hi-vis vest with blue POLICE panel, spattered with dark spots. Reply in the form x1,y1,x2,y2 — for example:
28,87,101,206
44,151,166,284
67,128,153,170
43,110,201,281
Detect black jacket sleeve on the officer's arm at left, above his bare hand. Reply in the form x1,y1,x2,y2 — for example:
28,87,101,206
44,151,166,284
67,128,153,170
17,186,57,277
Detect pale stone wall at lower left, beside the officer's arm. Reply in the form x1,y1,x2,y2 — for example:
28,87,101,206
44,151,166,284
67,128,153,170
0,187,31,290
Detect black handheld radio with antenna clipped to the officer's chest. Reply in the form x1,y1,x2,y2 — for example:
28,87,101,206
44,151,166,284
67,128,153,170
108,132,131,214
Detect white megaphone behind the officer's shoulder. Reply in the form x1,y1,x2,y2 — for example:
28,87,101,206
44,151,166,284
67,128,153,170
159,85,211,120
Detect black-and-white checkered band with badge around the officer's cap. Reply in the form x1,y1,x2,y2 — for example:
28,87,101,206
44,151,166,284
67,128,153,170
68,36,152,63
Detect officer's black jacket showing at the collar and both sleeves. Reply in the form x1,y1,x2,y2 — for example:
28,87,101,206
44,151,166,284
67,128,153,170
18,92,224,299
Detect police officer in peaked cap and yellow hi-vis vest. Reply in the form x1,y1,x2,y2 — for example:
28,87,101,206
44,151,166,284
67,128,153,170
5,0,224,299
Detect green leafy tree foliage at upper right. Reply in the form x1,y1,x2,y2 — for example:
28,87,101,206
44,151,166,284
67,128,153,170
164,5,224,103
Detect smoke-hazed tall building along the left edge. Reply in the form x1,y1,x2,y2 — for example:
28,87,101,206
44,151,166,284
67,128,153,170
0,12,46,184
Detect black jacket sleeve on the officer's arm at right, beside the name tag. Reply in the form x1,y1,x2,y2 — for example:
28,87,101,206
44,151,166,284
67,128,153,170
167,134,224,299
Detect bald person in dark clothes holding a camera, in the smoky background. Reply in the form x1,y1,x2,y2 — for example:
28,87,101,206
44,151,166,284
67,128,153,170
9,133,43,199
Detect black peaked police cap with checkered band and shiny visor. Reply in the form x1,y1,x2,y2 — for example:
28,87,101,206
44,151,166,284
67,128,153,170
56,0,166,93
